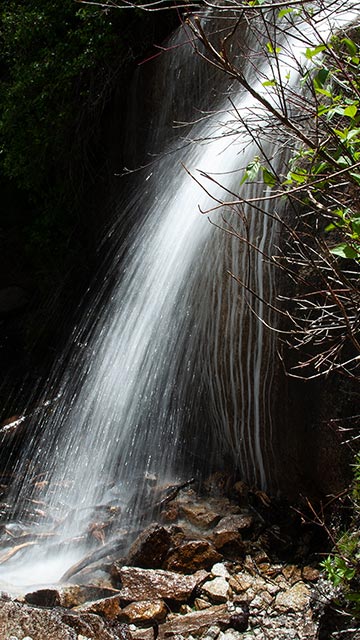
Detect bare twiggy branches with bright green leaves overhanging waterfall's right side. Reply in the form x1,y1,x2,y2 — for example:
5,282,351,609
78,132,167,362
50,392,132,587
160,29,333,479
188,0,360,378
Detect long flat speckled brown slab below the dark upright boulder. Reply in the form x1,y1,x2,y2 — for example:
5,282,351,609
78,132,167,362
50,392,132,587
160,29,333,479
115,567,208,602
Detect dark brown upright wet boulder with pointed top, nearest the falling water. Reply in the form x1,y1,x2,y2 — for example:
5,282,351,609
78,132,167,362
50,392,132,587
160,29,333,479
125,525,171,569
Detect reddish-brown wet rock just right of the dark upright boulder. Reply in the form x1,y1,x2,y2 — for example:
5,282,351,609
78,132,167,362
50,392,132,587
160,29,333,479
164,540,222,573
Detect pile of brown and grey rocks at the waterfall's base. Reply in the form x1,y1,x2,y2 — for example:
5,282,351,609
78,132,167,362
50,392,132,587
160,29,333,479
0,478,360,640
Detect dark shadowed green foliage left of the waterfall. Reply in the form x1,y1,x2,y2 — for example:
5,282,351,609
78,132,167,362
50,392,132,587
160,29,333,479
0,0,175,352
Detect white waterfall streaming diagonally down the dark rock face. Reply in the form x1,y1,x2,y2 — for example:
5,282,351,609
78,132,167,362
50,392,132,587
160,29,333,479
3,1,358,584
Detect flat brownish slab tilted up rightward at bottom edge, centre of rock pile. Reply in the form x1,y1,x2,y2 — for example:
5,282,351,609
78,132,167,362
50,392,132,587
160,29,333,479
159,604,230,640
